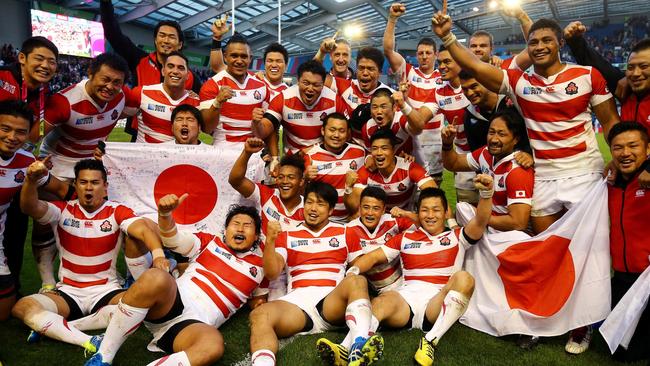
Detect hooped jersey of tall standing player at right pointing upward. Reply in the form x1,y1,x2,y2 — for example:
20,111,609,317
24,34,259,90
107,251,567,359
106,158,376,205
501,65,612,180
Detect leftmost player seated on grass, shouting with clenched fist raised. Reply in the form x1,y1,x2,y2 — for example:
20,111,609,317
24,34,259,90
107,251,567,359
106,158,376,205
12,159,169,352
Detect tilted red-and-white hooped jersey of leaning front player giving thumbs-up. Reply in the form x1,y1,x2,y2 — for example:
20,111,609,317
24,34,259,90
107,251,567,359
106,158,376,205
177,232,264,319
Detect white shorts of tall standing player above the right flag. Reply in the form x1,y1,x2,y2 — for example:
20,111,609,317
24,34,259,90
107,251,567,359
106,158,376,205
530,173,603,217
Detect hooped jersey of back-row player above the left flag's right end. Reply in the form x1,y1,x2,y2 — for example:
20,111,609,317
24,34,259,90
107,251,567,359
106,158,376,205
199,70,271,145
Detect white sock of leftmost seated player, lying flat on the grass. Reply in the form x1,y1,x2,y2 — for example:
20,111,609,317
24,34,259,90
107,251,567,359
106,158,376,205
24,311,91,346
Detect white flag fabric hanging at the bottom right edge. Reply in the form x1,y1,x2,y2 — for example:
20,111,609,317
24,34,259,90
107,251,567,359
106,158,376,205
600,258,650,354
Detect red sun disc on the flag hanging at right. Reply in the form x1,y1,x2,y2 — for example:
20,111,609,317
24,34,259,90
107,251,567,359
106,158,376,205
497,235,576,317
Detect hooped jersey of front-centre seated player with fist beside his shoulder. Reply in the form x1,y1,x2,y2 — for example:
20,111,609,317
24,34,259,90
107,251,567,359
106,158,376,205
275,222,354,292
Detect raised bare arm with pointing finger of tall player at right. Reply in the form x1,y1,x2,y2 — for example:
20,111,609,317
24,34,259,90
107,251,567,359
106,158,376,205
431,12,503,93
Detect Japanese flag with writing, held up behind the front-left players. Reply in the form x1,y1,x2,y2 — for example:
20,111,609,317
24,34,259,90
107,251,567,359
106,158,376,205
103,142,264,234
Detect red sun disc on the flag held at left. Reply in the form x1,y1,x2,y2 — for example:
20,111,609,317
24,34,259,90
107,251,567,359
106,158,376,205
153,164,219,225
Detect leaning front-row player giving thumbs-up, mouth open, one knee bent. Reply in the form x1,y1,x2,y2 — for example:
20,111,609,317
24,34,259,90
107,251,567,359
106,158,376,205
86,200,264,366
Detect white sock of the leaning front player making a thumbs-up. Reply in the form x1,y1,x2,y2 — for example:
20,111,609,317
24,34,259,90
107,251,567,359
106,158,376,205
97,299,149,364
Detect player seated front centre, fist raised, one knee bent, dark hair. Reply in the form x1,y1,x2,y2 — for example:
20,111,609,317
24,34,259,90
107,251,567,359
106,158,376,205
250,182,383,366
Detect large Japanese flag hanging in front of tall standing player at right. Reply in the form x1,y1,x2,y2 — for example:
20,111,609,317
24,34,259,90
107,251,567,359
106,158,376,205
456,182,611,336
